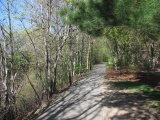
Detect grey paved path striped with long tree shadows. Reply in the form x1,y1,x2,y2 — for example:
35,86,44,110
37,64,105,120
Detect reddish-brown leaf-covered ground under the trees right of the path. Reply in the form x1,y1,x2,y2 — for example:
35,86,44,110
105,67,160,90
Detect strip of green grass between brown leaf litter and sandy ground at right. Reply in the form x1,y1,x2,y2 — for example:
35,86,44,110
110,80,160,109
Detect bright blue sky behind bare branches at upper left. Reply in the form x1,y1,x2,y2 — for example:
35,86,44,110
0,0,65,31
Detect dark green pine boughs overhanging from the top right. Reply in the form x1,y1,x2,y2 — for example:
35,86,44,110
61,0,160,35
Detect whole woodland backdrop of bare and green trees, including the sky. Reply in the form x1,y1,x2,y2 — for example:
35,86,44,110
0,0,160,120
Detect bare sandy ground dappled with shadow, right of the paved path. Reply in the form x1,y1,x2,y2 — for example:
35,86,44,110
102,81,160,120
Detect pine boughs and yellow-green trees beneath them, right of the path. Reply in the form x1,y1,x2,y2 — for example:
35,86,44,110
61,0,160,69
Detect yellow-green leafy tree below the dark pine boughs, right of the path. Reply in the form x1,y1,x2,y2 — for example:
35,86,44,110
104,26,143,66
